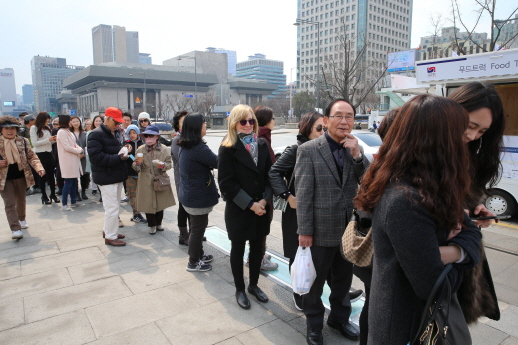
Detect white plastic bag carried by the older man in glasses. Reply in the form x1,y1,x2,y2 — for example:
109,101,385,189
291,246,317,295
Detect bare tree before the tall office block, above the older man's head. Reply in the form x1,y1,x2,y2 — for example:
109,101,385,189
306,22,387,108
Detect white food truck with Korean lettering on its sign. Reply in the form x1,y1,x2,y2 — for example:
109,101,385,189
392,49,518,215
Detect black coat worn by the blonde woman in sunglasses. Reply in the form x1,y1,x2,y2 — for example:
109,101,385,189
218,139,272,241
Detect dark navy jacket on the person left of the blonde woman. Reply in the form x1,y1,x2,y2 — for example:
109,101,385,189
178,143,219,208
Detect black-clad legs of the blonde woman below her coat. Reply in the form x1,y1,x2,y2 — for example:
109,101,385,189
230,237,264,290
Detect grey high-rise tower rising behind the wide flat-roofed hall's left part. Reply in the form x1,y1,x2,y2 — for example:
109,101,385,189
92,24,139,65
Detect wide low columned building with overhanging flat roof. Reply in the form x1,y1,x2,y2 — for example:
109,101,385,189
59,62,276,121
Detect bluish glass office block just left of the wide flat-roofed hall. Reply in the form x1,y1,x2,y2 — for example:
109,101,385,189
31,56,84,112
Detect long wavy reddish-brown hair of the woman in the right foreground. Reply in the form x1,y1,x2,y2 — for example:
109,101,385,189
355,95,471,230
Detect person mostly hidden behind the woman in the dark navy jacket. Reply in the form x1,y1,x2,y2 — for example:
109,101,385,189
171,110,190,246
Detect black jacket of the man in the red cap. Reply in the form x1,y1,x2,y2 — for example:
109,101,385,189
87,124,128,186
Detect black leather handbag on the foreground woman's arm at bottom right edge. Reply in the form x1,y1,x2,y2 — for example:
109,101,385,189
409,264,471,345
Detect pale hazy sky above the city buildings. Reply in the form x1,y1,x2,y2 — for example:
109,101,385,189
0,0,516,93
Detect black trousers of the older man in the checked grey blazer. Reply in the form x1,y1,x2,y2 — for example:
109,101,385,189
302,246,353,331
